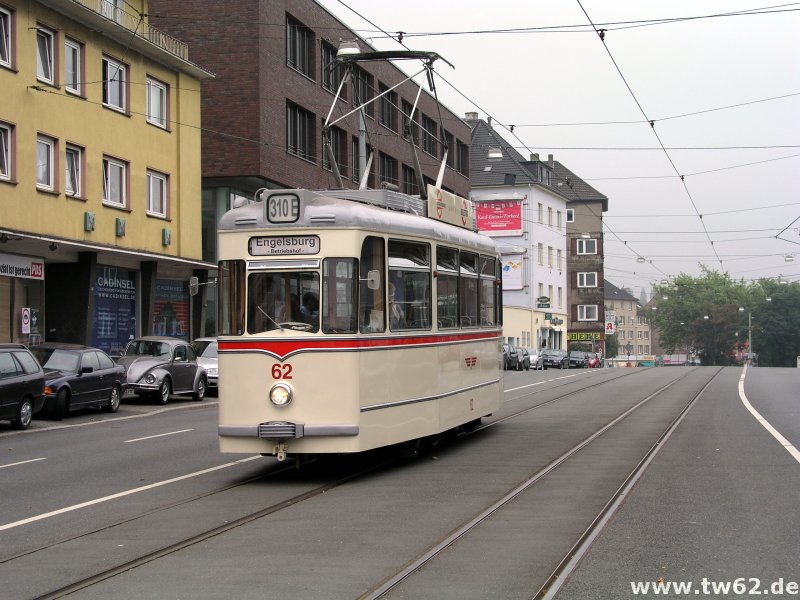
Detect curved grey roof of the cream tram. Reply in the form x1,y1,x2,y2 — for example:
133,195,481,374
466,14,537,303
218,189,496,253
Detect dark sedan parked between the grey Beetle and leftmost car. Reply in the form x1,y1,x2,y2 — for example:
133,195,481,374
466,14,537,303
31,342,125,421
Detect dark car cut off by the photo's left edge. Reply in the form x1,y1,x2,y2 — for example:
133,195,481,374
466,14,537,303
0,344,44,429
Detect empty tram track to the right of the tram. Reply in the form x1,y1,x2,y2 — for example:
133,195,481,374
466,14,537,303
359,368,722,600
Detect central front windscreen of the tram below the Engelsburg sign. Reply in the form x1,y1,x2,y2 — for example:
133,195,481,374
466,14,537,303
247,271,319,333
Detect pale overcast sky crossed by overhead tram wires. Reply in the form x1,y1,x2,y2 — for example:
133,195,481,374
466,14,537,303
319,0,800,297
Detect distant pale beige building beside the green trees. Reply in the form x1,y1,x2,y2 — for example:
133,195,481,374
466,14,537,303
604,281,654,360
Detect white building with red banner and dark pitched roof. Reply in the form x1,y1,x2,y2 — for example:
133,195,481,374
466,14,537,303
466,113,569,349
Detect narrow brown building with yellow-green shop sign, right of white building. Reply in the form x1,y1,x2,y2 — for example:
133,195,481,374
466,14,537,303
552,161,608,354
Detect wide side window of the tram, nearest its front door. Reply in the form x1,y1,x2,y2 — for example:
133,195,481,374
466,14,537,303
387,240,431,329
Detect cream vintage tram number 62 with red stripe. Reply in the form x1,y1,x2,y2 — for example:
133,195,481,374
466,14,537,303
212,48,503,460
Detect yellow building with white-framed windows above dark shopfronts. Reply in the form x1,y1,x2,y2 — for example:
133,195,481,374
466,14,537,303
0,0,214,354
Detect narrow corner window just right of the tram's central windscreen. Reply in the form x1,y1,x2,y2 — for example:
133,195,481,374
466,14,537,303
322,258,358,333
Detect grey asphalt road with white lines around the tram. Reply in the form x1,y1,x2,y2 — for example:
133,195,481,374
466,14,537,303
0,368,800,600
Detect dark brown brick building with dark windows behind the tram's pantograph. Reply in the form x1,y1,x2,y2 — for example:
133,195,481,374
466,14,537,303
149,0,470,268
